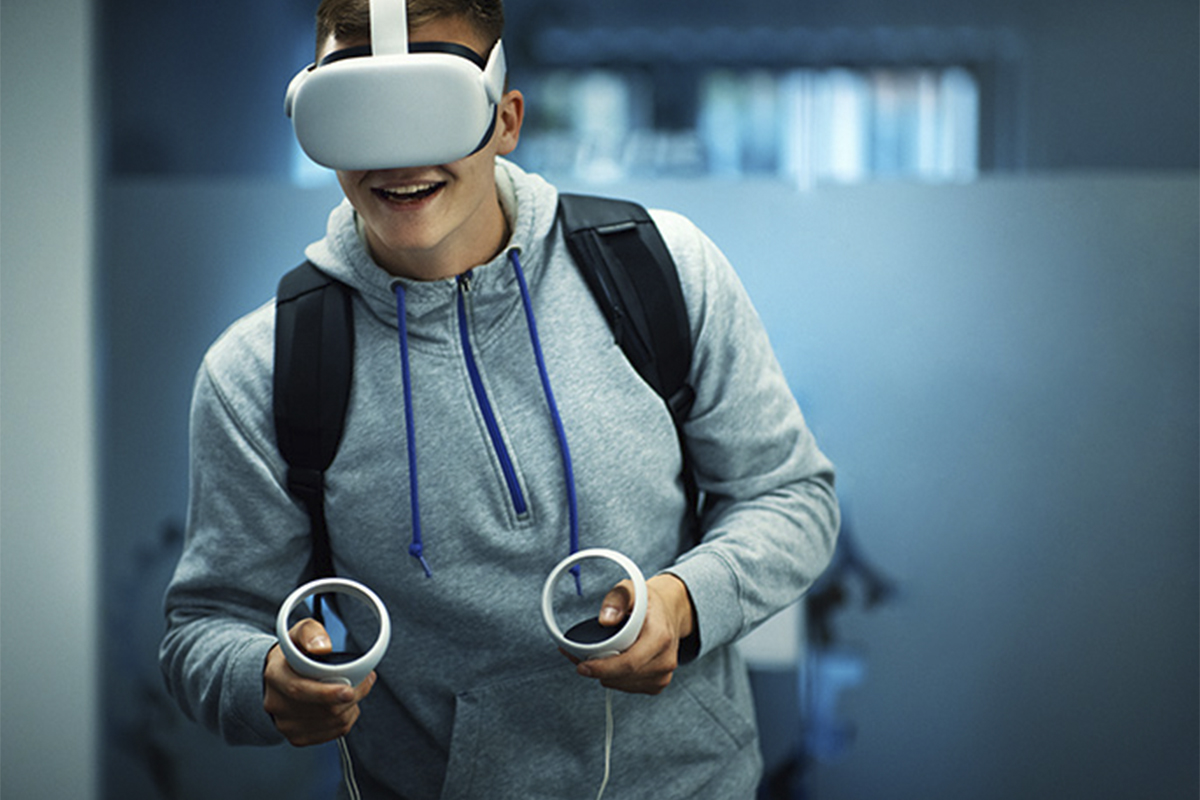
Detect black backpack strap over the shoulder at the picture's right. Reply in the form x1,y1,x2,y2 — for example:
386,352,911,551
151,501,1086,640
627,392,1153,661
558,194,700,511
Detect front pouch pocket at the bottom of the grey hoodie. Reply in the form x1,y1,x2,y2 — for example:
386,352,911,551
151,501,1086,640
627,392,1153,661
442,664,760,800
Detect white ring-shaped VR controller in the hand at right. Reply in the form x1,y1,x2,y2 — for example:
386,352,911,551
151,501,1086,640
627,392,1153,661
541,548,647,661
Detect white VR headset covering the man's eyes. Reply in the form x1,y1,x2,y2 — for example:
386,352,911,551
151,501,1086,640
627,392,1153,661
284,0,505,170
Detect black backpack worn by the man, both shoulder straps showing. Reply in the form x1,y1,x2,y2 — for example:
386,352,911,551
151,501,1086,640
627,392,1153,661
274,194,698,577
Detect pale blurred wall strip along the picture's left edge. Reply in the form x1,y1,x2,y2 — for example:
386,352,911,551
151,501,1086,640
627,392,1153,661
0,0,97,800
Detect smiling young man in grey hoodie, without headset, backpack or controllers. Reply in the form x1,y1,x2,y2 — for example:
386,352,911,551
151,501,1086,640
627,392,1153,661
162,0,838,800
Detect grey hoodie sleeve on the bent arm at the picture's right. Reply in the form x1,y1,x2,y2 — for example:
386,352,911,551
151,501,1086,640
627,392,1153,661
654,211,839,654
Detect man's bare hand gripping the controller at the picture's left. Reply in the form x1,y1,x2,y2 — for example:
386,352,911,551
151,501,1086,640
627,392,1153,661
263,619,376,747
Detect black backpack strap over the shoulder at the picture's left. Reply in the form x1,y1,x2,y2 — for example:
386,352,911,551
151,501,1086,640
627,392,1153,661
274,261,354,577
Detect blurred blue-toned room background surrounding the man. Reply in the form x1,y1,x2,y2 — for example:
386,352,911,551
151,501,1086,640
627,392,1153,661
0,0,1200,800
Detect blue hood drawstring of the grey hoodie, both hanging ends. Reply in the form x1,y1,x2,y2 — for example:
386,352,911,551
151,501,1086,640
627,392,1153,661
394,249,583,596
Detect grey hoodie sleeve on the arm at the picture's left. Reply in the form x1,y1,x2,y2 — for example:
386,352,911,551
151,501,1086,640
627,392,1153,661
160,307,308,745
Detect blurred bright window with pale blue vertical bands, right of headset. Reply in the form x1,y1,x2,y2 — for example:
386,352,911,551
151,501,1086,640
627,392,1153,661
515,66,979,186
